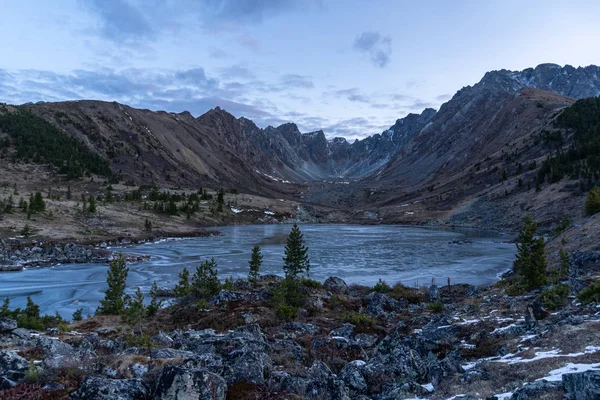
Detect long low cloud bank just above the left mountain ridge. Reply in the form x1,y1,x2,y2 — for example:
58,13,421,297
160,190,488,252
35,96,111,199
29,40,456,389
0,67,279,123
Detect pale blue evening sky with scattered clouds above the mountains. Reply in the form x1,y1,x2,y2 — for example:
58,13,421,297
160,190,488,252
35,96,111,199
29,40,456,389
0,0,600,139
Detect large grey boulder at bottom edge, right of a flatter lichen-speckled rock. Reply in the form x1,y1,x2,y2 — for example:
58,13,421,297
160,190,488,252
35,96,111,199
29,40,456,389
153,366,227,400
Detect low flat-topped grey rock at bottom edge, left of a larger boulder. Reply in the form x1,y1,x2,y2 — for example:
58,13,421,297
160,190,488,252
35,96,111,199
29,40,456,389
71,376,148,400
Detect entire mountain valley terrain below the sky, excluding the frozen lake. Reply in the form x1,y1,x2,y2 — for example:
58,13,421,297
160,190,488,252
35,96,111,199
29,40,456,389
0,64,600,400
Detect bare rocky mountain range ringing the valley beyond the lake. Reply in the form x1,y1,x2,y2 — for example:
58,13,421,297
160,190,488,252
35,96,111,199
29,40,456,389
8,64,600,222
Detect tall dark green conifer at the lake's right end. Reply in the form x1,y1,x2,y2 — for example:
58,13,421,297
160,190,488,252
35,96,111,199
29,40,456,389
513,214,547,290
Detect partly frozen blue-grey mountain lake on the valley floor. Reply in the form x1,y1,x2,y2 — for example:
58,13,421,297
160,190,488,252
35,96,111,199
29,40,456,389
0,225,516,319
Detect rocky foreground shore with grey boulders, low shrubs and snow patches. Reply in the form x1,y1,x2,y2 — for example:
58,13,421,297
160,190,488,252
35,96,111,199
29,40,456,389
0,277,600,400
